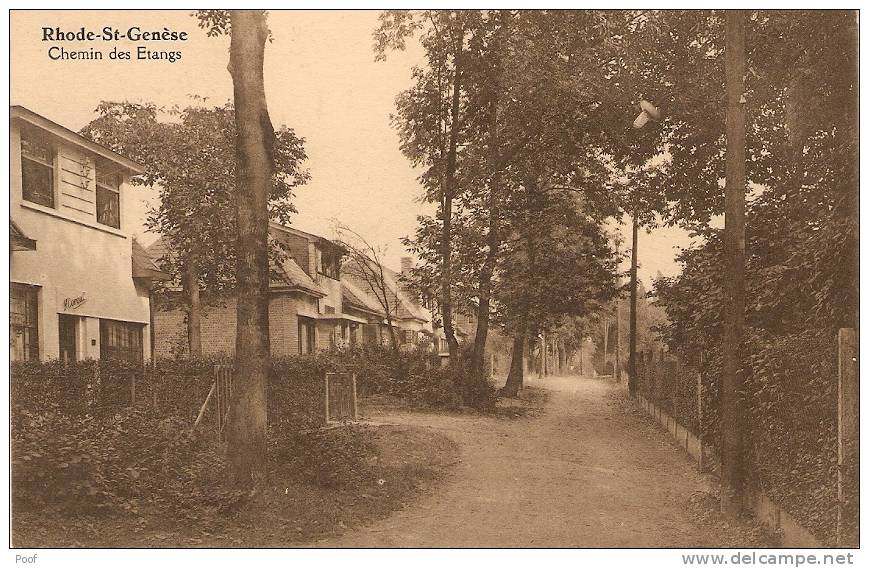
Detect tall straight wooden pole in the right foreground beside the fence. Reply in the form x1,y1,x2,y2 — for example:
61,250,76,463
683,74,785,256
721,10,745,518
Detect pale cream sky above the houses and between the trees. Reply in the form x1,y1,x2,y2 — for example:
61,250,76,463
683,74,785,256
10,10,690,285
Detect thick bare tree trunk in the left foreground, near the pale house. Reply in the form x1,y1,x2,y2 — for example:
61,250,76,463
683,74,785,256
226,10,274,488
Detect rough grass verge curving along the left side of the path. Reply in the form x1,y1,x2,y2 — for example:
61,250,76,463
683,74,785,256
12,426,458,548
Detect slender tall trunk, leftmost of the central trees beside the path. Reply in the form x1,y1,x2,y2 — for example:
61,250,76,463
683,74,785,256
441,25,465,365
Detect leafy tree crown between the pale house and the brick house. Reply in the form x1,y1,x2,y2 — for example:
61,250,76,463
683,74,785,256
81,99,309,294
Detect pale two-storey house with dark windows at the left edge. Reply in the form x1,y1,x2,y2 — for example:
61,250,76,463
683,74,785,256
10,106,165,361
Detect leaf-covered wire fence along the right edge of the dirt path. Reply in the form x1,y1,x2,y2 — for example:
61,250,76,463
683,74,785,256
637,331,858,544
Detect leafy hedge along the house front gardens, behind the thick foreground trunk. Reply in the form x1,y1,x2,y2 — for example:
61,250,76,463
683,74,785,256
10,348,492,521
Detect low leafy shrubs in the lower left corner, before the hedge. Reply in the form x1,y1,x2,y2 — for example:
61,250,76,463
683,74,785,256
11,409,242,519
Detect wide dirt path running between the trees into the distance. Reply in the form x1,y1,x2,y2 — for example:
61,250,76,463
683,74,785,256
317,377,760,547
